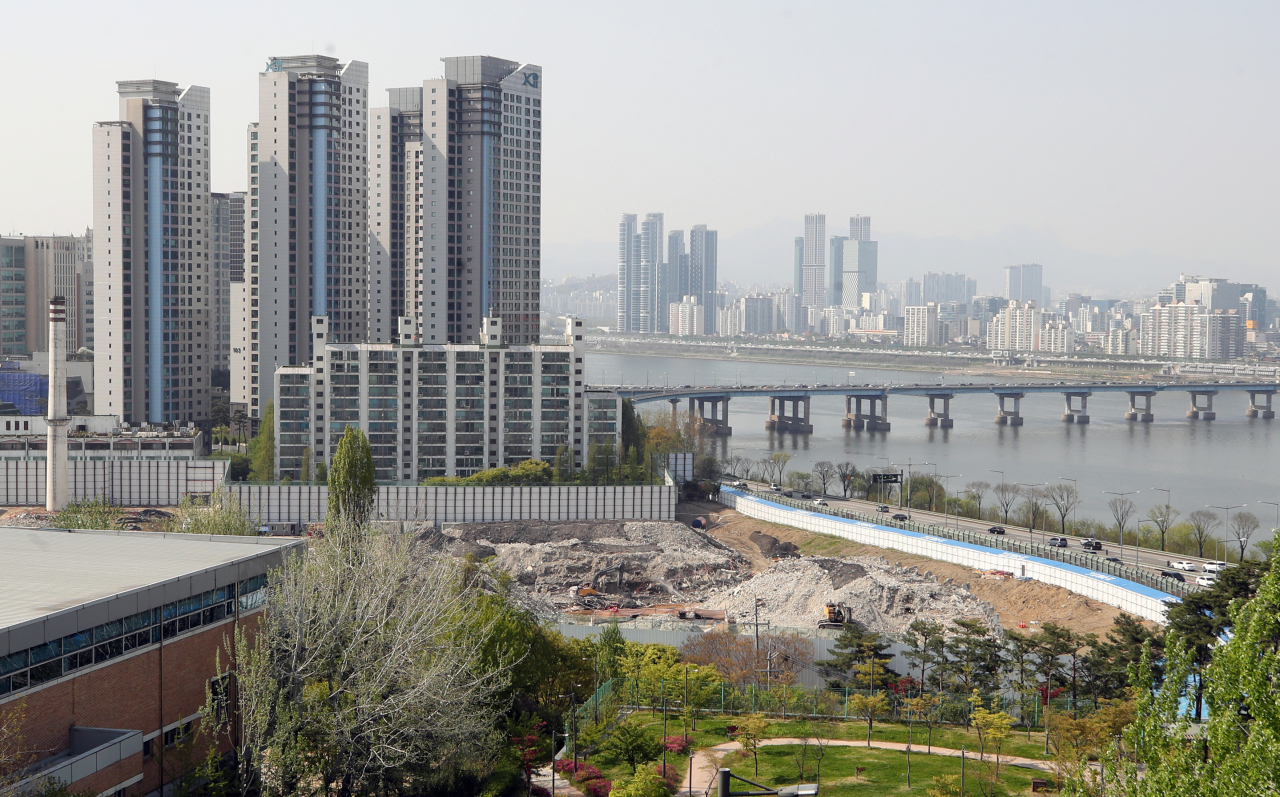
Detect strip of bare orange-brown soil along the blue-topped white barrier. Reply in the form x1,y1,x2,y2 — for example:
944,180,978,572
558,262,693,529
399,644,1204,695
676,501,1120,635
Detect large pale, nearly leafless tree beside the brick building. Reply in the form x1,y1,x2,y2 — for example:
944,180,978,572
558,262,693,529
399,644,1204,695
201,517,512,797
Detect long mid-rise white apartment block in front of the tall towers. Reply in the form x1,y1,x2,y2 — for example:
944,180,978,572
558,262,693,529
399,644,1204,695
275,317,621,482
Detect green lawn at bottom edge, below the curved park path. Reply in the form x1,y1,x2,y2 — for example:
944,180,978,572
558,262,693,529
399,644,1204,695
716,745,1052,797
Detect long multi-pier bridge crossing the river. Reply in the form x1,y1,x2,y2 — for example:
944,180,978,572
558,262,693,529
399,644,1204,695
612,381,1280,435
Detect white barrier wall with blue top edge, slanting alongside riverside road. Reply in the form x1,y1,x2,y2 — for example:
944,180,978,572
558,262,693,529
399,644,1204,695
719,487,1178,623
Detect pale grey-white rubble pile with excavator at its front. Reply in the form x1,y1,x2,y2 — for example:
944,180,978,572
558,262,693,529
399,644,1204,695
703,556,1000,635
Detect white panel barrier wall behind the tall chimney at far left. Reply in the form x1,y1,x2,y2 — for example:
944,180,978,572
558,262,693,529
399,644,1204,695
0,459,227,507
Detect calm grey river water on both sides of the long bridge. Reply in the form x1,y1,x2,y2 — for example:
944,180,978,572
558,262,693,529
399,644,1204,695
586,349,1280,542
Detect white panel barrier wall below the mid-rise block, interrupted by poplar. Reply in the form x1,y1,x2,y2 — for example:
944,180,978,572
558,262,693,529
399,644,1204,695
228,480,677,523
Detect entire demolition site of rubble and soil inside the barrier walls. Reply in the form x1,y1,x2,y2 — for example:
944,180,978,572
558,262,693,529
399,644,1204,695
404,501,1119,637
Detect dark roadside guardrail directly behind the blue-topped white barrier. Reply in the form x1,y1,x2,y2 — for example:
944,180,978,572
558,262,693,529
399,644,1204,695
735,487,1199,597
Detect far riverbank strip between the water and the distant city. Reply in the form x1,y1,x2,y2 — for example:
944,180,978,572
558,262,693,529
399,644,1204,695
588,338,1160,380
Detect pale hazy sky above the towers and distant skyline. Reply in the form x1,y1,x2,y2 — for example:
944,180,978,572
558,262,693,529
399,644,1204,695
0,0,1280,292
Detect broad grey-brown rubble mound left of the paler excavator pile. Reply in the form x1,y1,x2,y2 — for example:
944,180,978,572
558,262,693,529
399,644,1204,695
406,521,751,615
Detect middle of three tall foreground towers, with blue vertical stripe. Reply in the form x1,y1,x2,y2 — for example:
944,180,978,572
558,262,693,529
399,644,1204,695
230,55,370,418
